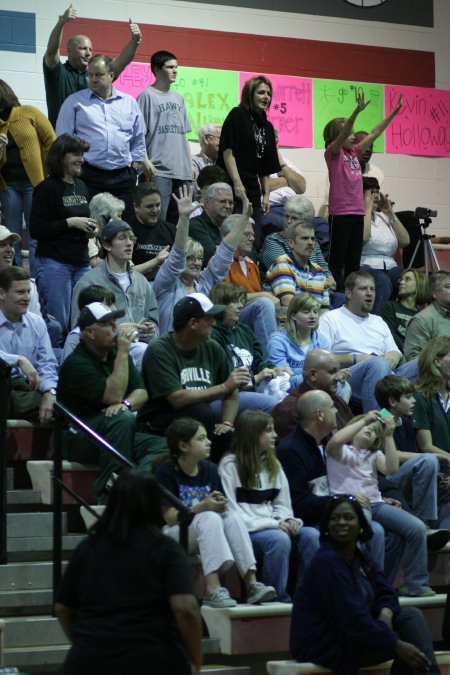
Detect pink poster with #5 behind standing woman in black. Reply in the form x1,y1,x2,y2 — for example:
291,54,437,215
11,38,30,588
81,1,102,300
239,73,313,148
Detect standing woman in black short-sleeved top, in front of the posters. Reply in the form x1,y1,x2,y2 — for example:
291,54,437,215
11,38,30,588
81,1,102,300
217,75,281,247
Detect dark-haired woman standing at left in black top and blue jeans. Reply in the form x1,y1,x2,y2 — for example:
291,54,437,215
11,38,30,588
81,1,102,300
30,134,97,337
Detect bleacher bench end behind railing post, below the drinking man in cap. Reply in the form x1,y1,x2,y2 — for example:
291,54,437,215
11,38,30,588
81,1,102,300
27,460,99,504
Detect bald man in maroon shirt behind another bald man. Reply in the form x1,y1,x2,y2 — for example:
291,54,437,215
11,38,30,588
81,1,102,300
272,349,353,439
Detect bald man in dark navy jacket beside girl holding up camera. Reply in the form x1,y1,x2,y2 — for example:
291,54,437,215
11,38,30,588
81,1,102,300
277,389,384,567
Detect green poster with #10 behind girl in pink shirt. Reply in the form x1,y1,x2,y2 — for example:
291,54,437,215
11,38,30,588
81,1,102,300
313,79,385,152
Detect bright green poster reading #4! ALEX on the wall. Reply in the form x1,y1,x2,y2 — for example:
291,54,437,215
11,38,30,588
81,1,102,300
172,66,239,141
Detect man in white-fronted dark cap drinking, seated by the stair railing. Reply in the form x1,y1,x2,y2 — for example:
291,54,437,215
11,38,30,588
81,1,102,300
57,302,167,499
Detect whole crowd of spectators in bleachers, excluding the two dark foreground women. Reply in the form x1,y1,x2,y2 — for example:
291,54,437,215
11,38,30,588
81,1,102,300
0,6,450,672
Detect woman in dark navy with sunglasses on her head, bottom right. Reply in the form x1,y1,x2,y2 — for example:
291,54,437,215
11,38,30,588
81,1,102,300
290,495,440,675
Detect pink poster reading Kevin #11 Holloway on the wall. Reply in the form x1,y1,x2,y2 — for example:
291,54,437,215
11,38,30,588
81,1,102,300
384,85,450,157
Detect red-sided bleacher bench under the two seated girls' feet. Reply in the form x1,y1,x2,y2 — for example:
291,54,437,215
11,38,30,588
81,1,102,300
201,593,447,656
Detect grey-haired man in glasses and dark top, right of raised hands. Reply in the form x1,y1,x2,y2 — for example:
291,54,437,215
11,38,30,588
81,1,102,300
189,183,234,266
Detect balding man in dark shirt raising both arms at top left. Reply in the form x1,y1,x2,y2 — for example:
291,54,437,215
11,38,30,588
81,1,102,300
43,5,142,127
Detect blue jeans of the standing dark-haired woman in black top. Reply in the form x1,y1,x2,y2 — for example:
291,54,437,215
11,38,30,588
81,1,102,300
36,258,91,339
